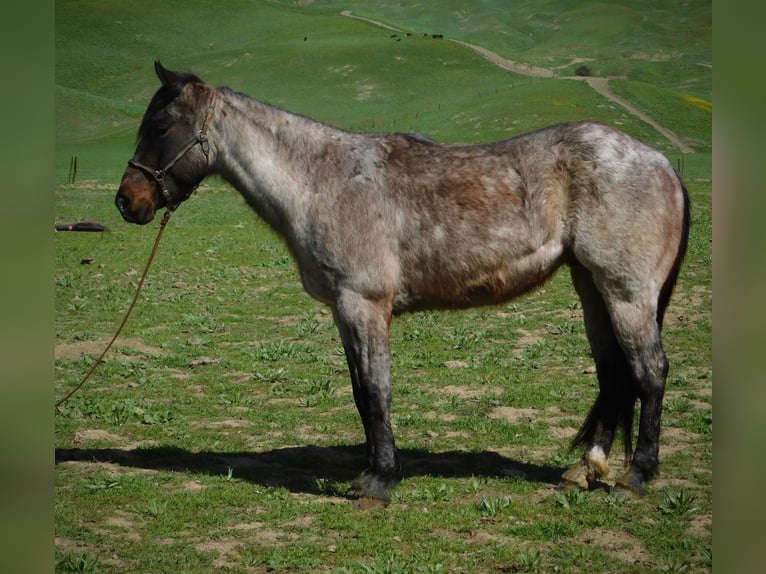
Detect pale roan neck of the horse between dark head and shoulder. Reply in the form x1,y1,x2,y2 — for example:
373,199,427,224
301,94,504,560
210,92,343,236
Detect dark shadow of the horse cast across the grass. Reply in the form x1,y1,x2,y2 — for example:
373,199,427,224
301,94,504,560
55,444,565,496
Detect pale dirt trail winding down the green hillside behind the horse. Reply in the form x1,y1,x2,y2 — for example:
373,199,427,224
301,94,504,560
341,10,694,153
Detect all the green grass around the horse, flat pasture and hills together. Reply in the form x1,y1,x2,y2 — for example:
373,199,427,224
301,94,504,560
54,0,713,574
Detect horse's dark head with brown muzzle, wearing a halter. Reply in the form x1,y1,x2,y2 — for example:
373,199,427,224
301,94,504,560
114,61,215,225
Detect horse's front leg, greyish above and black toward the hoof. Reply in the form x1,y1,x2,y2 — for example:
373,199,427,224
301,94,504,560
333,293,401,502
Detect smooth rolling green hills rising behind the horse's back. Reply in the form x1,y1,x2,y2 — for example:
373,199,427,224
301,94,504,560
56,0,712,182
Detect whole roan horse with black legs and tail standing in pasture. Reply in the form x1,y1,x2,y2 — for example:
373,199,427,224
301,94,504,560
115,62,689,501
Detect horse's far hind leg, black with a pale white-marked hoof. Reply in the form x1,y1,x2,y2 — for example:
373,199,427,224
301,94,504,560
561,263,636,489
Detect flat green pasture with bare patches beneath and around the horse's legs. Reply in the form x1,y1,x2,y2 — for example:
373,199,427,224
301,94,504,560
55,181,712,572
